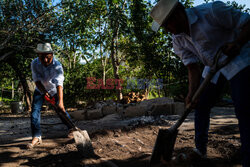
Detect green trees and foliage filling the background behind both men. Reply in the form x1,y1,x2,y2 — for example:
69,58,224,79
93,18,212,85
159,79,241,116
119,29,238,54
0,0,249,105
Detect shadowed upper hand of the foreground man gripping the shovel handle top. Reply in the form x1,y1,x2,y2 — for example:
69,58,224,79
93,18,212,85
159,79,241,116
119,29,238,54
222,42,241,58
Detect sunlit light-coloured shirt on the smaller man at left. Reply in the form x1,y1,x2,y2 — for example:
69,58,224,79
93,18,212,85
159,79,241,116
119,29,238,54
31,58,64,96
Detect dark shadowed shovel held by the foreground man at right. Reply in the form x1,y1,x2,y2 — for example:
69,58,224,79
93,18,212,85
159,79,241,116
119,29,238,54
150,49,232,166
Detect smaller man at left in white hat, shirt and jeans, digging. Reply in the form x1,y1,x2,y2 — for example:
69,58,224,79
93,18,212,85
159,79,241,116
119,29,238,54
28,43,72,148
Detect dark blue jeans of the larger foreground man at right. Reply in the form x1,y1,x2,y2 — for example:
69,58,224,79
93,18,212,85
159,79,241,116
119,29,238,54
195,66,250,167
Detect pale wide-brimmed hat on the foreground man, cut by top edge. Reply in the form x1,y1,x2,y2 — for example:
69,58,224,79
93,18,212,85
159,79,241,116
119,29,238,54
150,0,178,32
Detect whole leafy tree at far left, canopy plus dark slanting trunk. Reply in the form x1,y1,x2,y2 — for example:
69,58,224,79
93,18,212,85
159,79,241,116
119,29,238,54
0,0,59,110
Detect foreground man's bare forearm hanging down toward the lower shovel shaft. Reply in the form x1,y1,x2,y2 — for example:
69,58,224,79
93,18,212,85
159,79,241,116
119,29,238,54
185,63,201,105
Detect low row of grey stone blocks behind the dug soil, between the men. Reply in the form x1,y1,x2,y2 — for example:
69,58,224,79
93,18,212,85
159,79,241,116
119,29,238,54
70,97,185,120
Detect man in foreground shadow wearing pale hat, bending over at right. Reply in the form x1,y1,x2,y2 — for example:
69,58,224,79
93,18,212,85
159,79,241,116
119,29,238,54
150,0,250,167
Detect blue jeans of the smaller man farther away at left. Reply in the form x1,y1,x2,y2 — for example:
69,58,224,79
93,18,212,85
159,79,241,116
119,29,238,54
31,90,71,137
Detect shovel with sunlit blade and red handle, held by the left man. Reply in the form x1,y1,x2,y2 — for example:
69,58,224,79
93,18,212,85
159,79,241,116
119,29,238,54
44,96,94,156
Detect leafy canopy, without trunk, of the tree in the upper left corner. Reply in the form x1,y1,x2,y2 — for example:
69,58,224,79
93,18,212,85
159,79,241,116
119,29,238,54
0,0,56,57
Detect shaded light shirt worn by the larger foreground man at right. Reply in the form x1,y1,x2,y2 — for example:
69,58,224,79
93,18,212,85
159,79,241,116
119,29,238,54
173,1,250,83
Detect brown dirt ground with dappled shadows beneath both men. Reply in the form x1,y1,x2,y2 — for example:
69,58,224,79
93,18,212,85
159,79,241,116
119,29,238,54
0,107,241,167
